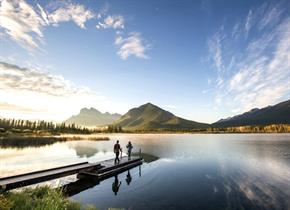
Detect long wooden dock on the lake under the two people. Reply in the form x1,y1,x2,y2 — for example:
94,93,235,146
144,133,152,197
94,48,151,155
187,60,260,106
0,157,142,191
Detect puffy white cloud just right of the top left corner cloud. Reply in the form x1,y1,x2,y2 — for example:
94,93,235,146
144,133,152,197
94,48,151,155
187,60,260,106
48,4,95,28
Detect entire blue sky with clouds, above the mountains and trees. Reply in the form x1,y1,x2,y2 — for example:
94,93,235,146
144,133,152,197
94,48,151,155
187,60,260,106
0,0,290,122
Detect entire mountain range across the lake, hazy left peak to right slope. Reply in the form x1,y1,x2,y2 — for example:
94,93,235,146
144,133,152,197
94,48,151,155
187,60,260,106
65,100,290,130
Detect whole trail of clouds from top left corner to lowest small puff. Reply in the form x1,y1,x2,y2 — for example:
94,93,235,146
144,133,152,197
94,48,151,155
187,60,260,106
0,0,149,60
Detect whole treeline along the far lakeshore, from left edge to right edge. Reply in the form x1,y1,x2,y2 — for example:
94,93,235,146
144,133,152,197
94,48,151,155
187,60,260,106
0,118,290,134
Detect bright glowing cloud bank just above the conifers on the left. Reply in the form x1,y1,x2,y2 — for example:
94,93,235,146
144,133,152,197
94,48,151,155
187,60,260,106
0,62,107,120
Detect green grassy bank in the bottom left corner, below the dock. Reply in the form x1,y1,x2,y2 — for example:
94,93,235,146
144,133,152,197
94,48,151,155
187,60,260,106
0,187,96,210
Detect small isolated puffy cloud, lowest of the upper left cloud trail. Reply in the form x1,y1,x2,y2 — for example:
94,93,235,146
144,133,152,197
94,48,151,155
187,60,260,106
115,32,149,60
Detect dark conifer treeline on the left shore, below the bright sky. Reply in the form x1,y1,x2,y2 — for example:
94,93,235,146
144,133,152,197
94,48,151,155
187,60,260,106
0,119,92,134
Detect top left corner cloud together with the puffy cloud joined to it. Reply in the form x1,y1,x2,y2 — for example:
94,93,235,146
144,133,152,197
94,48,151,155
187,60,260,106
0,0,94,51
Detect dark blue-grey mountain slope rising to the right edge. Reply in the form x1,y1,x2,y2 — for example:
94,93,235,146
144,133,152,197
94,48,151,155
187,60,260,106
212,100,290,127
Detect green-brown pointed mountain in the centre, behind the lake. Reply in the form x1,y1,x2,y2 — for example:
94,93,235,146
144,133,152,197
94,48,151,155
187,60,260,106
113,103,208,130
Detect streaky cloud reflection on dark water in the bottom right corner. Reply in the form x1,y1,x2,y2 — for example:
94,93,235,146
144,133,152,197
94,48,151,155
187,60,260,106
216,157,290,210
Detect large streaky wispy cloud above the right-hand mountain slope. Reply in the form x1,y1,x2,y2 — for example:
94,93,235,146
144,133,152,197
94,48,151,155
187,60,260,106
208,0,290,112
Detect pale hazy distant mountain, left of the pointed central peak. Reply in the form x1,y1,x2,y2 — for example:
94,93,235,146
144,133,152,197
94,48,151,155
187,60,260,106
65,108,121,126
